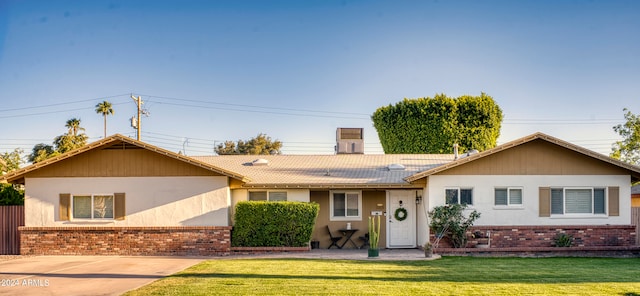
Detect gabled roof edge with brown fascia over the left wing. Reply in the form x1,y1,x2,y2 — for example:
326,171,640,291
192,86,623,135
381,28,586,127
0,134,249,182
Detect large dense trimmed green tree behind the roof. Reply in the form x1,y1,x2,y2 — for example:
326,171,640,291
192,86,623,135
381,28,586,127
371,93,502,154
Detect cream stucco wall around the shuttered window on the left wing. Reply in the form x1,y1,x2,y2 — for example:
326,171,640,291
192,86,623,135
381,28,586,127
25,177,231,226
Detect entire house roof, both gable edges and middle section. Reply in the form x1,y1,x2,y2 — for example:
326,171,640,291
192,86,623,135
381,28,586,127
6,133,640,188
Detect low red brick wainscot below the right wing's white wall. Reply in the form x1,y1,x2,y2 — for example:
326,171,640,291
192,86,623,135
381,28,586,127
431,225,637,249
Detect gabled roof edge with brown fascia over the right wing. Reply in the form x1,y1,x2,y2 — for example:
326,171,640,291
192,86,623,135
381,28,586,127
405,133,640,182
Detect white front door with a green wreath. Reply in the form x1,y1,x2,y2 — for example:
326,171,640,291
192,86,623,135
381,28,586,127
387,190,416,248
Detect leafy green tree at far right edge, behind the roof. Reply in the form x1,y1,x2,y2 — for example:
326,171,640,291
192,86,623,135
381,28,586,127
611,108,640,165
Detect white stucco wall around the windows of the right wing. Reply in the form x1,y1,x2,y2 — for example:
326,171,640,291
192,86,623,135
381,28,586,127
423,175,631,225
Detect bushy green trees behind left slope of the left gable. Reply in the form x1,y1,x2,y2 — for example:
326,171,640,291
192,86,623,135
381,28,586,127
28,118,89,163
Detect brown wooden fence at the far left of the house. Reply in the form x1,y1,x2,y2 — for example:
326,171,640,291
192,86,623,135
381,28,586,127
0,206,24,255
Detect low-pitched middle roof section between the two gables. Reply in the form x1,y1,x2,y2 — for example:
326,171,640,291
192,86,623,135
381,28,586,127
193,154,453,188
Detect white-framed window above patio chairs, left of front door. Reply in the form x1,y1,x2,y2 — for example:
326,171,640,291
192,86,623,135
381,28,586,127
329,191,362,221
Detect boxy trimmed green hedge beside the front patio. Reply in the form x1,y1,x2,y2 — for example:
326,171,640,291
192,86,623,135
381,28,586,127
231,201,320,247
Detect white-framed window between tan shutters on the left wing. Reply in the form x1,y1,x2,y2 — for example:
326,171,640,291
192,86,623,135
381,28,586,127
71,194,114,219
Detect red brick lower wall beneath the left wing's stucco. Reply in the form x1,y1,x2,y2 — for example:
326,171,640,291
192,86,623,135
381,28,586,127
19,226,231,256
